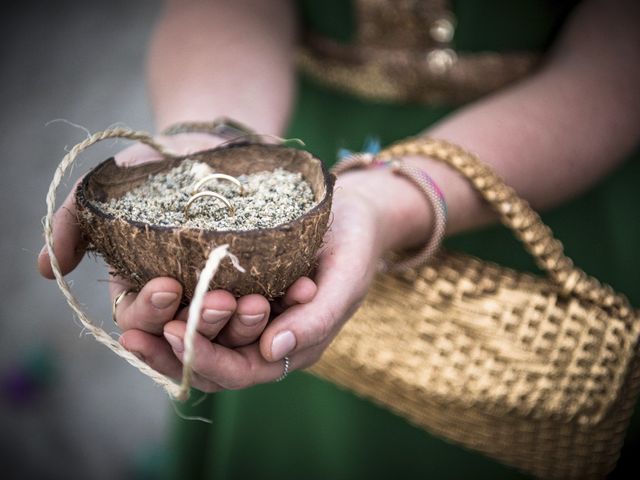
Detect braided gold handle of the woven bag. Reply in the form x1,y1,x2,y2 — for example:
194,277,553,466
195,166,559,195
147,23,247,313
378,137,632,318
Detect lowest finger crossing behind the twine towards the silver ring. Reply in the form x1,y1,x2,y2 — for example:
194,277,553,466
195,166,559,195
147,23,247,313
164,321,284,390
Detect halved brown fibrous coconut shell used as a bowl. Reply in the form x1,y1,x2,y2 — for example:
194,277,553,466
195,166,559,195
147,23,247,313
76,143,335,300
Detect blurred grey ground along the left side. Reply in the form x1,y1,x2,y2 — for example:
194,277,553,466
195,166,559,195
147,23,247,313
0,0,171,479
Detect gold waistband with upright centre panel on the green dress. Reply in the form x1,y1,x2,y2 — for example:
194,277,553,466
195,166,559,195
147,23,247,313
297,0,539,104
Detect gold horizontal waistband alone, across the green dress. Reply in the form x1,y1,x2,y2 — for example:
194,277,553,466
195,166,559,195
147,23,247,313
298,37,539,104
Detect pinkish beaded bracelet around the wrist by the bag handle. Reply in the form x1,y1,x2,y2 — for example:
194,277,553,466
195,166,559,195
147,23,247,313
331,153,447,271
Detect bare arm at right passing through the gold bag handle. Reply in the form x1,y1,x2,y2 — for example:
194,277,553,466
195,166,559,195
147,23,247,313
364,0,640,248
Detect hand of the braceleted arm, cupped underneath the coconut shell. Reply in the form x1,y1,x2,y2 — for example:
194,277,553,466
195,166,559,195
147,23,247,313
118,167,436,392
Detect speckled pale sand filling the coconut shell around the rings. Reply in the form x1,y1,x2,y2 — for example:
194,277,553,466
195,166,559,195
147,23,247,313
97,160,317,231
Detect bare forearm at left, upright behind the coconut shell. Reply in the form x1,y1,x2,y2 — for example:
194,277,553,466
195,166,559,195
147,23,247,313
148,0,295,134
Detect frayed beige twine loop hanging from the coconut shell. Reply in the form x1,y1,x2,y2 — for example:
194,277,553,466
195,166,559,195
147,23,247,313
44,127,244,401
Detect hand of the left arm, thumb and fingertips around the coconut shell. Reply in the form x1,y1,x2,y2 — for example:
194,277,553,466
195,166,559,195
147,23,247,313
38,133,292,352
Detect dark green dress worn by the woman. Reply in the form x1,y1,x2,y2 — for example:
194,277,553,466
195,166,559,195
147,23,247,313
164,0,640,480
